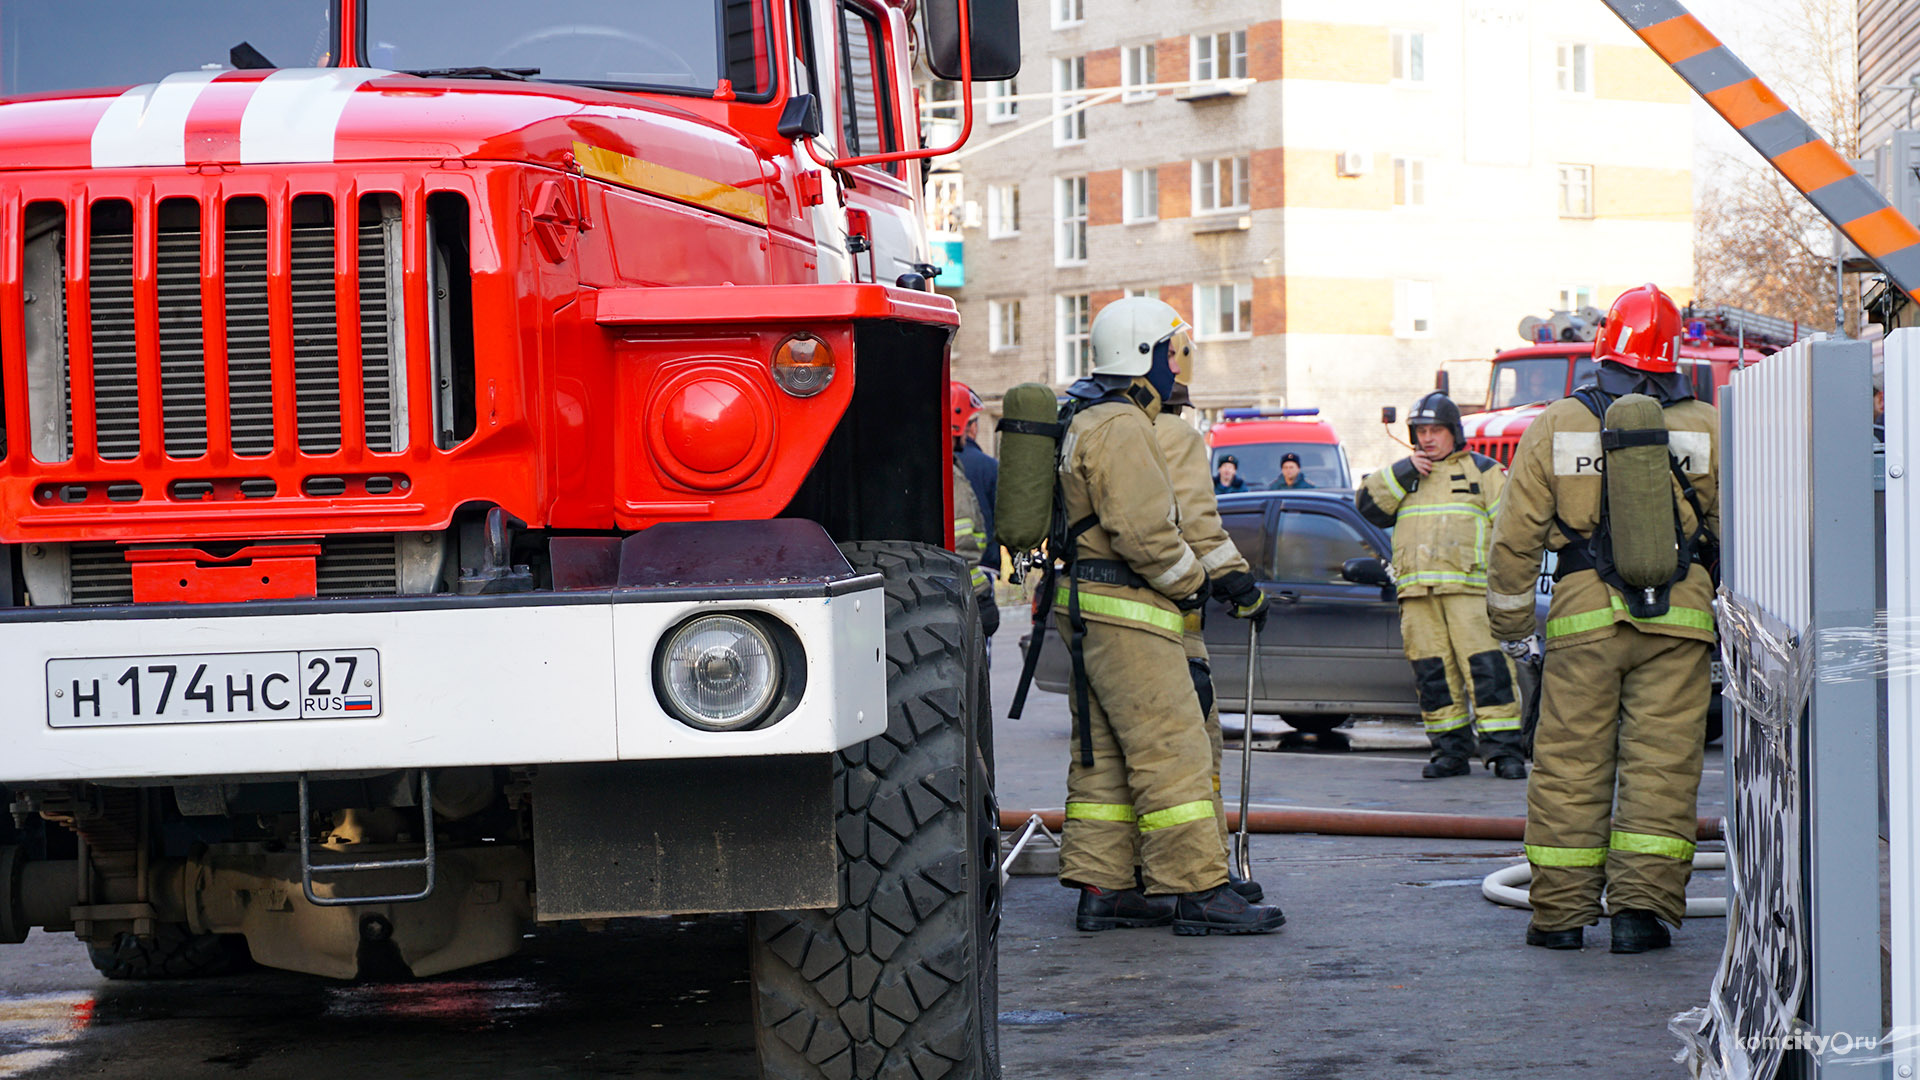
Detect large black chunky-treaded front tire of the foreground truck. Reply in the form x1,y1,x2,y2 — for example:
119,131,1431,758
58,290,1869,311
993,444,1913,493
751,542,1000,1080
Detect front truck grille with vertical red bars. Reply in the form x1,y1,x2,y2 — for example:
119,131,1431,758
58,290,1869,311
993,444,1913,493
23,194,407,463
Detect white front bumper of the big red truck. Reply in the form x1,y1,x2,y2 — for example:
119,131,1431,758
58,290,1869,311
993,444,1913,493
0,576,887,784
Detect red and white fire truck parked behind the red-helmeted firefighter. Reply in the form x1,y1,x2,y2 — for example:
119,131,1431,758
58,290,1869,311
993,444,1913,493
1434,306,1799,465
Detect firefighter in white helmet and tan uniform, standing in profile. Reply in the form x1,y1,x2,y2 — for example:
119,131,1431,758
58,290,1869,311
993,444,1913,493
1054,298,1286,934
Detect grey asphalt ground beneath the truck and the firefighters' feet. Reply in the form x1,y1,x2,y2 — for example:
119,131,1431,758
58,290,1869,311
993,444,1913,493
0,611,1724,1080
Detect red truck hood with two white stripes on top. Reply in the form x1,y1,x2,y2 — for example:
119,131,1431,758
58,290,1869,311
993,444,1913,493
0,67,766,211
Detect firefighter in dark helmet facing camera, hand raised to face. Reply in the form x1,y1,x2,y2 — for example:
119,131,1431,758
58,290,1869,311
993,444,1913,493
1354,392,1532,780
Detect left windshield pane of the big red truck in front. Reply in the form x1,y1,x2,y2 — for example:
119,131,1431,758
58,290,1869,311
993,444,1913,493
0,0,334,98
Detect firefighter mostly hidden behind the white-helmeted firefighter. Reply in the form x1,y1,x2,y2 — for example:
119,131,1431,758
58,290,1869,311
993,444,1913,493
1154,372,1267,903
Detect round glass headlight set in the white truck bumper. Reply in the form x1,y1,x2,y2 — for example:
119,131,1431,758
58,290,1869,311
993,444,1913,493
655,615,783,730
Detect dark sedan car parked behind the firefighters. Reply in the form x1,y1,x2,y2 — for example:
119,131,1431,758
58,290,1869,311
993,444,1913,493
1035,490,1548,732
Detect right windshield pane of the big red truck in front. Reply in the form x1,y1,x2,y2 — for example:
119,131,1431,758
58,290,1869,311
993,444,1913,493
365,0,772,98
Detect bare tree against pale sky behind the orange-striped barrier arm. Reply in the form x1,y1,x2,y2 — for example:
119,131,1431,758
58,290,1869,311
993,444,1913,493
1693,0,1860,332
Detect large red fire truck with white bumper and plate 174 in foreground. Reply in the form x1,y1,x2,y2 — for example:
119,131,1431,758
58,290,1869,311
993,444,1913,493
0,0,1020,1078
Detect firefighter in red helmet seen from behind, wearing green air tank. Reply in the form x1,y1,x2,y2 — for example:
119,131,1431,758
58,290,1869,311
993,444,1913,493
1486,284,1720,953
